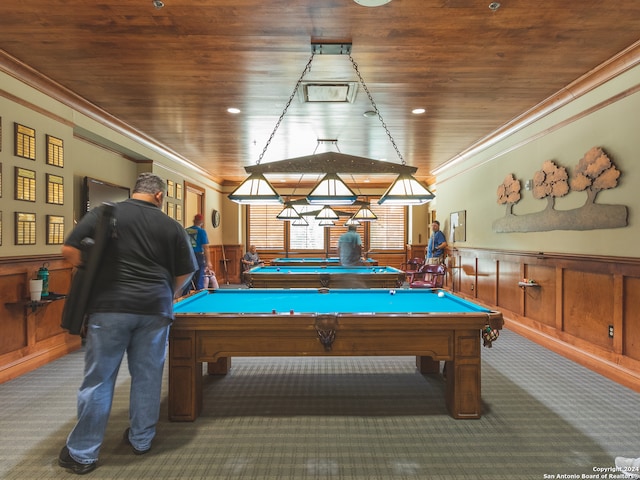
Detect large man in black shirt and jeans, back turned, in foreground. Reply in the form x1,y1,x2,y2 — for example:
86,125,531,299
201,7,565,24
58,173,197,474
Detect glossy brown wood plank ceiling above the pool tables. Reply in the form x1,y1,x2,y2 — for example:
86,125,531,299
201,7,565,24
0,0,640,188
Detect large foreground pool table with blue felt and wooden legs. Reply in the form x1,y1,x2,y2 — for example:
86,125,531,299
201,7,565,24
168,289,503,421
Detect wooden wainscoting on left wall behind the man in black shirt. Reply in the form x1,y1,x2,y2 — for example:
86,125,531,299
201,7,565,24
0,255,81,383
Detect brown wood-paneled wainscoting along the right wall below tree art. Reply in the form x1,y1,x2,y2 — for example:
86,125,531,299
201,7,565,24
447,248,640,392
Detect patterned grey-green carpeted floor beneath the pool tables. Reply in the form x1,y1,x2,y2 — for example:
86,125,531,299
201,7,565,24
0,330,640,480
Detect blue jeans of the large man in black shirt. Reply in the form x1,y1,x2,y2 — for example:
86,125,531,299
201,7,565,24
67,313,171,463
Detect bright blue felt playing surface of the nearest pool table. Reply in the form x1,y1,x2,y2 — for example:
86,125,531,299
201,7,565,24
174,288,490,314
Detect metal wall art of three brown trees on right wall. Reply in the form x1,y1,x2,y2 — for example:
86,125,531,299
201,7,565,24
493,147,628,233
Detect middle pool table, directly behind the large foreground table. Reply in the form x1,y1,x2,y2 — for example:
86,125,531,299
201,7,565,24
242,265,405,288
